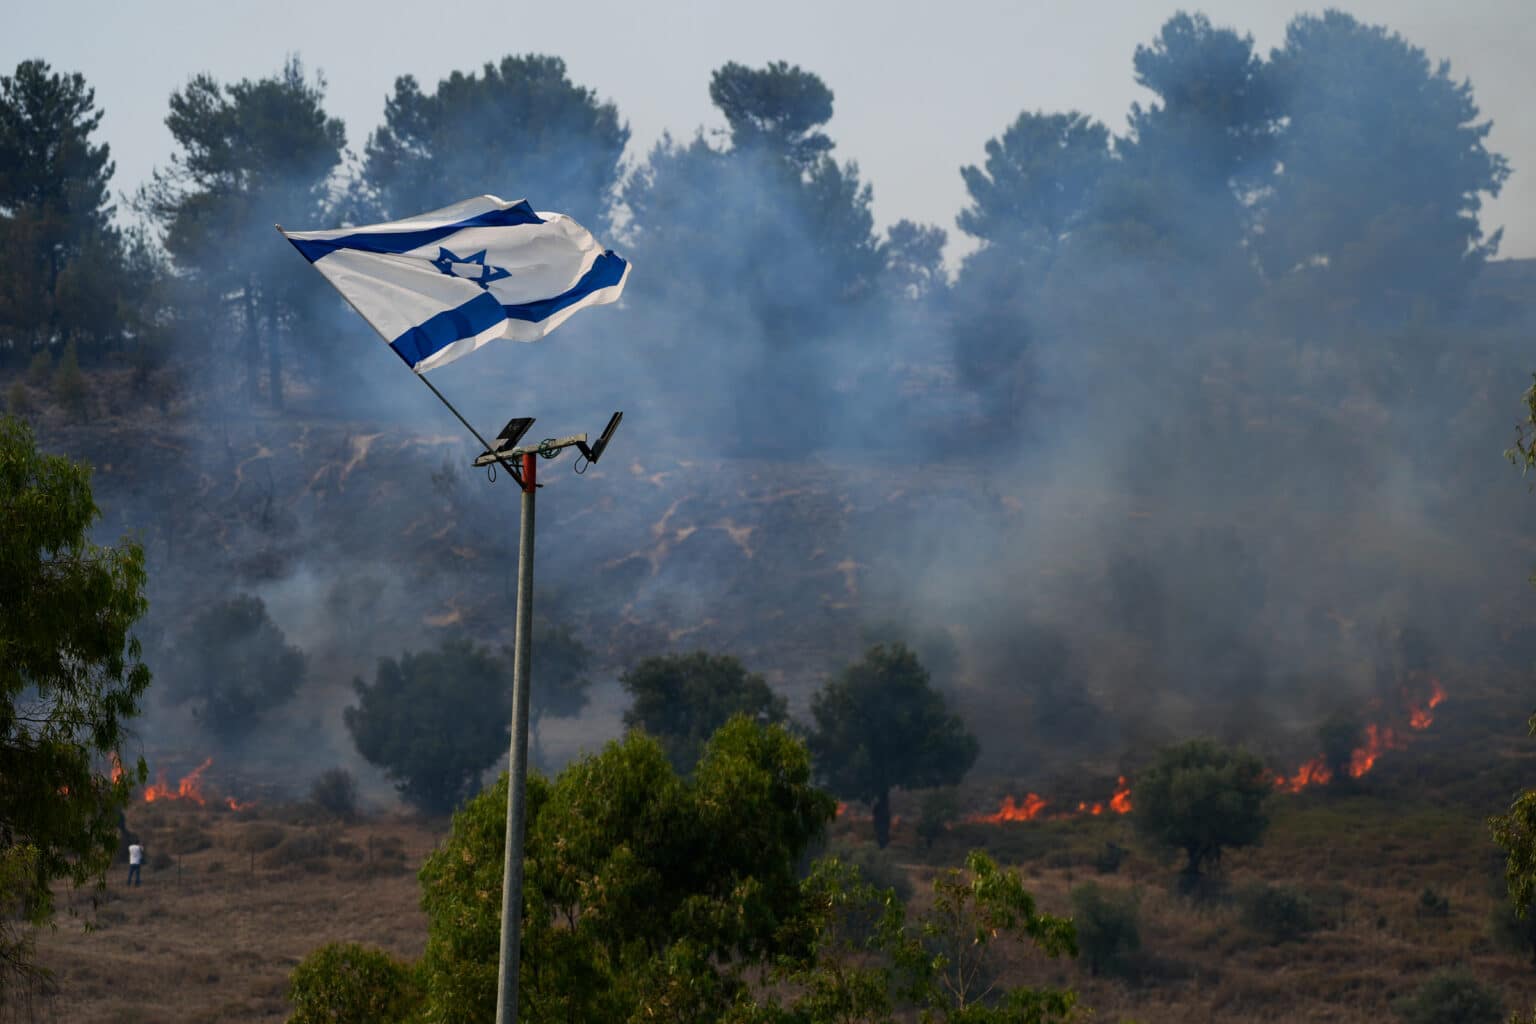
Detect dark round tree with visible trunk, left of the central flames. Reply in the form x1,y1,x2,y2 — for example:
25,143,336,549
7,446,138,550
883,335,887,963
809,643,980,847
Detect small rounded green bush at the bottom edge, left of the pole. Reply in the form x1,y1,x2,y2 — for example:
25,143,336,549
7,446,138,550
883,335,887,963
289,943,419,1024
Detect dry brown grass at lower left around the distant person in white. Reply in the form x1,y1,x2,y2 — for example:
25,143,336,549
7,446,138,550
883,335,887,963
38,804,439,1024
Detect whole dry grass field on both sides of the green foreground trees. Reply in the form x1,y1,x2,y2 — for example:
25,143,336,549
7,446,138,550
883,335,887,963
27,675,1536,1024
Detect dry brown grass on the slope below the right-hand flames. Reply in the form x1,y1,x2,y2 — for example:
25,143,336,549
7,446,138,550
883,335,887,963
833,783,1536,1024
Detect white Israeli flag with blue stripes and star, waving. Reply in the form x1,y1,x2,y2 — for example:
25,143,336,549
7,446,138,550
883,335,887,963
278,195,630,373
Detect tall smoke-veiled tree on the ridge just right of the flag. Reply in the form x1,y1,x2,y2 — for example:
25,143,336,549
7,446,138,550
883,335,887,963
624,61,886,450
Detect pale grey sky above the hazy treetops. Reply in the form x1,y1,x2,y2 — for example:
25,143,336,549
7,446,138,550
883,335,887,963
0,0,1536,258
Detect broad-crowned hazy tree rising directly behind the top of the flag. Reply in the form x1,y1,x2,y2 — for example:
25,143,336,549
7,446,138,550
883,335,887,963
362,54,630,225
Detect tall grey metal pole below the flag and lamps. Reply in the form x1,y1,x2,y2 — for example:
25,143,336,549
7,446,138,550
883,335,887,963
487,445,539,1024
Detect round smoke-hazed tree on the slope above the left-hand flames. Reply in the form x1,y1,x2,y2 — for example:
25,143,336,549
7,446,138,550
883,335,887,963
166,594,307,740
